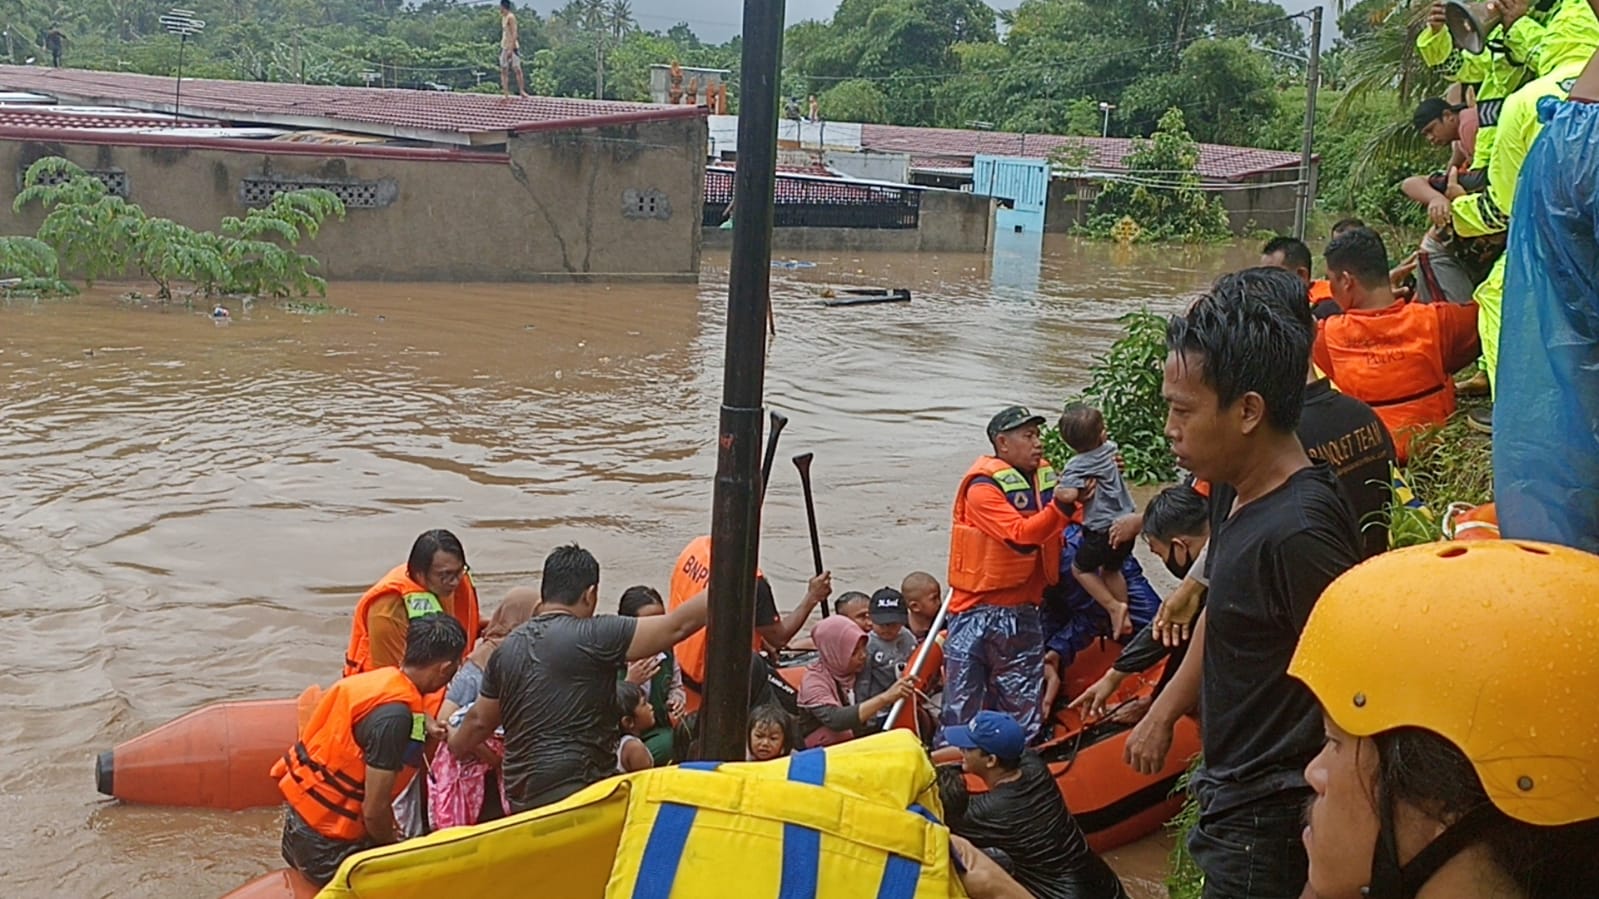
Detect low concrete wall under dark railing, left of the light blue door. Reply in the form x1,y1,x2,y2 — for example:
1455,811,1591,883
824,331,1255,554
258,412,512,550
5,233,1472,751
705,190,995,253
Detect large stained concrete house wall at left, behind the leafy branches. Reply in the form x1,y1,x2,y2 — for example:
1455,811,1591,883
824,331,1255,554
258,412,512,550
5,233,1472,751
0,112,705,282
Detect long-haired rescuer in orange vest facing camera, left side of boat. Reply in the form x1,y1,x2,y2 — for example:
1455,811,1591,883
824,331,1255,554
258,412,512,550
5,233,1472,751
344,528,481,677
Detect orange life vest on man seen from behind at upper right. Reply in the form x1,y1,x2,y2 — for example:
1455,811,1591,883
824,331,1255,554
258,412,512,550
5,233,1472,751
1318,301,1455,465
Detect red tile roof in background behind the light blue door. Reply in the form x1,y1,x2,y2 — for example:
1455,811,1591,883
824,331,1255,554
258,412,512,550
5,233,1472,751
860,125,1298,181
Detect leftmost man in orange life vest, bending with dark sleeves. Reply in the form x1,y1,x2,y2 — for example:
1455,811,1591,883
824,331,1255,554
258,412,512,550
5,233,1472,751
272,614,467,886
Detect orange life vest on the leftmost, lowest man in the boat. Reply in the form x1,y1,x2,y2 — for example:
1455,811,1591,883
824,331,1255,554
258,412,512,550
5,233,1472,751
272,669,425,843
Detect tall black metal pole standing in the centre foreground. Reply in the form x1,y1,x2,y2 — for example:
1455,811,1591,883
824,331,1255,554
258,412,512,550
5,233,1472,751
700,0,784,761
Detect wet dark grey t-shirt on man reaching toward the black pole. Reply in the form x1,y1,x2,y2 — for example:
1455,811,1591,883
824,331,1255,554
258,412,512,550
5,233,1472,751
480,613,638,811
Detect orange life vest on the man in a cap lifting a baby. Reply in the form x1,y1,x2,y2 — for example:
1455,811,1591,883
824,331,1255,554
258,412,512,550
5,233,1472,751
950,456,1063,593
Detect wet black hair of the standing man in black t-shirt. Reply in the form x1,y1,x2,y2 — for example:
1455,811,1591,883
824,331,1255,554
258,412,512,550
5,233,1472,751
1166,267,1314,432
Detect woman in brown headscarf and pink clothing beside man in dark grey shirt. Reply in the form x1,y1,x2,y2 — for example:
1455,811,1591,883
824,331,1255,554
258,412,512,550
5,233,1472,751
427,587,539,830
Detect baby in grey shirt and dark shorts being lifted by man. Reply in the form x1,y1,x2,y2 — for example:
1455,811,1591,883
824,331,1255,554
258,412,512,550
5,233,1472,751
1060,403,1137,637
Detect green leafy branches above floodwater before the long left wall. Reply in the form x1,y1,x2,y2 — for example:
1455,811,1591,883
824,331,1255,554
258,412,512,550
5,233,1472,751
12,157,344,299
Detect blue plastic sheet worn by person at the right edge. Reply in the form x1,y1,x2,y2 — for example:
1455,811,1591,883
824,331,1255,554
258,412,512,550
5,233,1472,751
1493,99,1599,552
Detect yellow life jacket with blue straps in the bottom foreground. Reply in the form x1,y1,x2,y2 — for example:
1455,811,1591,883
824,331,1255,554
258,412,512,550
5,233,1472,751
295,731,964,899
